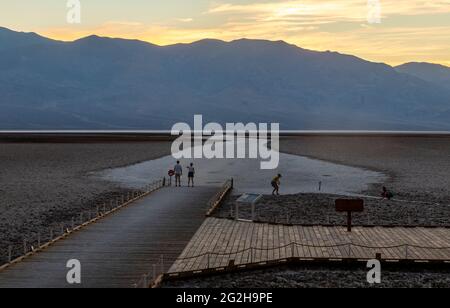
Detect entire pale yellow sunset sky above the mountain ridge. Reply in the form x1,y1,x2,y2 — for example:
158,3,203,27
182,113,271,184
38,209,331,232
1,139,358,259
0,0,450,66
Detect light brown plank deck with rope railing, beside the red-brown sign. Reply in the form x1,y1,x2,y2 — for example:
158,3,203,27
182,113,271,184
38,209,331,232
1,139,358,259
169,218,450,274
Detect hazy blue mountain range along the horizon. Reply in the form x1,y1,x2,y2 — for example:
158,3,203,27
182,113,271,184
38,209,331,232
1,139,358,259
0,28,450,130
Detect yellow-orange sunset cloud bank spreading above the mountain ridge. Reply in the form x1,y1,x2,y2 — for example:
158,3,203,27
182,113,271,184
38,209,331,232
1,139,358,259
36,0,450,64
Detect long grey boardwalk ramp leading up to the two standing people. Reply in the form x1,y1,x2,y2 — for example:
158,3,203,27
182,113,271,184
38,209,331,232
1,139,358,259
0,187,217,288
